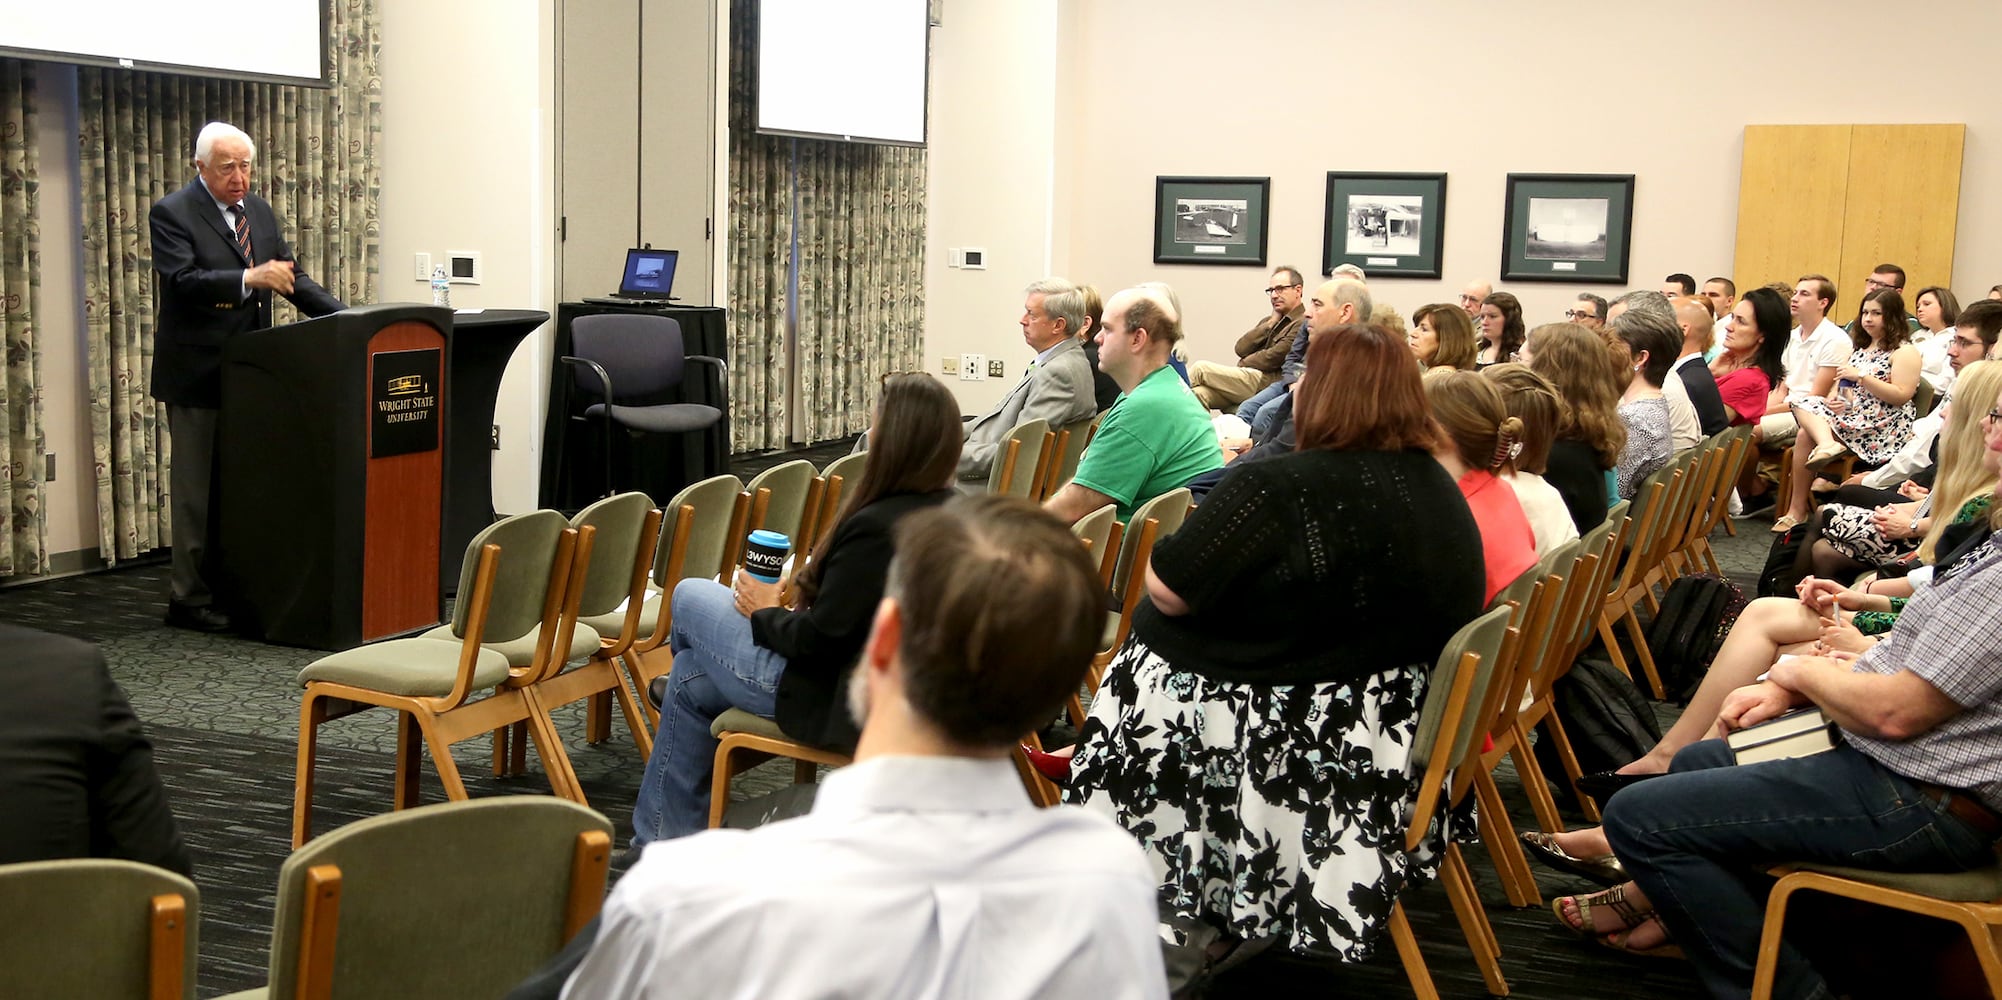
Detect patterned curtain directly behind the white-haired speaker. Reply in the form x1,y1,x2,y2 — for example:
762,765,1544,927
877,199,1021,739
78,0,382,562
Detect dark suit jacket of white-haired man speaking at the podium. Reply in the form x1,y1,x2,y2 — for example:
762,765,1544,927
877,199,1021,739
150,178,342,410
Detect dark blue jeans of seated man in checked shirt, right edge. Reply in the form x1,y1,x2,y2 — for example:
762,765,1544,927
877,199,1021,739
1606,740,1994,1000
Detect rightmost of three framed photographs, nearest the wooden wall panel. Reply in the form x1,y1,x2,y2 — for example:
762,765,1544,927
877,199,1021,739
1502,174,1634,284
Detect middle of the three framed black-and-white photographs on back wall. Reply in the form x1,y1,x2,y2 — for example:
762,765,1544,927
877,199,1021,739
1321,170,1445,278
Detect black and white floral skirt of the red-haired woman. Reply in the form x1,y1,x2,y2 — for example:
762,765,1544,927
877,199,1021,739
1069,638,1443,962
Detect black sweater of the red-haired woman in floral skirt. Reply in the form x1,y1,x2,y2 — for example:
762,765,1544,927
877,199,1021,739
1133,450,1485,684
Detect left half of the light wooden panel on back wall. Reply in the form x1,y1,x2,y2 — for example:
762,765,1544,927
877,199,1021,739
1732,124,1852,304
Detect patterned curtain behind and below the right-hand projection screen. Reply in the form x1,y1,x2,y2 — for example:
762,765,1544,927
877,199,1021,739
729,0,925,450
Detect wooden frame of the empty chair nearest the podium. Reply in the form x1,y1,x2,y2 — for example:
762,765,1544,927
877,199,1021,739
292,528,595,848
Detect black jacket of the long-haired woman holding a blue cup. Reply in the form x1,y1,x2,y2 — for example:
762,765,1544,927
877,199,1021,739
751,490,959,752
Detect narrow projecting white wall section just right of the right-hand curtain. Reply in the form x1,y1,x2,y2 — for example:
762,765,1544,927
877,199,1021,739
925,0,1059,412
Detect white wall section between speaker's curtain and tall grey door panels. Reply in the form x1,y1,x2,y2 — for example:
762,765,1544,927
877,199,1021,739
378,0,557,514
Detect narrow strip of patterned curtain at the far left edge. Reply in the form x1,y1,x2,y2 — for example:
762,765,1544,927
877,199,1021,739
0,60,48,576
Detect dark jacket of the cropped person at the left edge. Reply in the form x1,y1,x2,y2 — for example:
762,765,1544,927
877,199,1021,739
0,624,194,878
